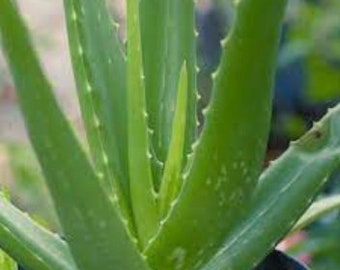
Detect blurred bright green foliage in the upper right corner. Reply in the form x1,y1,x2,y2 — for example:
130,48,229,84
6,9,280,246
283,0,340,102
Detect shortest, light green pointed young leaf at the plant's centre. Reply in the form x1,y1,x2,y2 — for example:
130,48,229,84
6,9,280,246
159,63,188,217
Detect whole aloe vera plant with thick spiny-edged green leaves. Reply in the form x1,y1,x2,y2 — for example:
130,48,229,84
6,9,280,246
0,0,340,270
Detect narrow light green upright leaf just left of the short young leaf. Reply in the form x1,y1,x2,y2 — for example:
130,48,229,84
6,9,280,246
127,0,159,247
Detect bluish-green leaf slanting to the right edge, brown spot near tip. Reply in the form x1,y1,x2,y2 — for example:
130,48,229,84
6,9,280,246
203,106,340,270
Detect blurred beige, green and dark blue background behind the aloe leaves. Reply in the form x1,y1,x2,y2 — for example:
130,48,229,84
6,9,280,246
0,0,340,270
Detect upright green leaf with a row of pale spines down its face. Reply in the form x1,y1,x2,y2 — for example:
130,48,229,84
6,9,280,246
64,0,131,218
